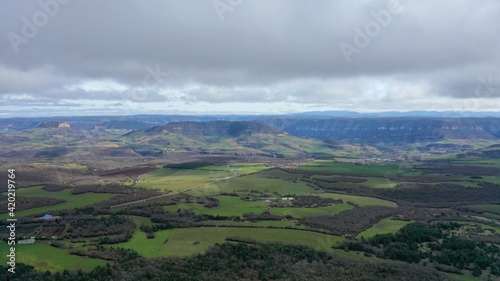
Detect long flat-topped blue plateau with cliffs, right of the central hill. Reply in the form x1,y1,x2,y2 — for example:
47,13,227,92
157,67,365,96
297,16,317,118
265,118,500,144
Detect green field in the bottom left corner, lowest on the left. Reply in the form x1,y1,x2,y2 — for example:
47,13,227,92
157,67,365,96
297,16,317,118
0,242,107,272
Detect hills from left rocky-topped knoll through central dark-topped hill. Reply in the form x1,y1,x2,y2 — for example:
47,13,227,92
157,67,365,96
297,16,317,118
0,121,386,158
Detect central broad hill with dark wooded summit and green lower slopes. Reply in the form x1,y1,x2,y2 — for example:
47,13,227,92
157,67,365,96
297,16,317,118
120,121,364,158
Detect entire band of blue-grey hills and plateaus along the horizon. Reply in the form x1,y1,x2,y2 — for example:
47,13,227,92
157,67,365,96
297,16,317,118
0,114,500,156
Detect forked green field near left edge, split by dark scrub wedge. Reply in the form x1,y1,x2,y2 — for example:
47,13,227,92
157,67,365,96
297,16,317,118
0,186,116,219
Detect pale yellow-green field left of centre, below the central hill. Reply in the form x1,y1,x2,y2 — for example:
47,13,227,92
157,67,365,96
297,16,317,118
135,168,233,191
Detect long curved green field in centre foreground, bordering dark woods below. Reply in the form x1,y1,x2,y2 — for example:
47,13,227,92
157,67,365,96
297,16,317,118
159,227,344,257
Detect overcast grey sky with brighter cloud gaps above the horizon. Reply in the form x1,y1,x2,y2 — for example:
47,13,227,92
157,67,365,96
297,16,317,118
0,0,500,117
